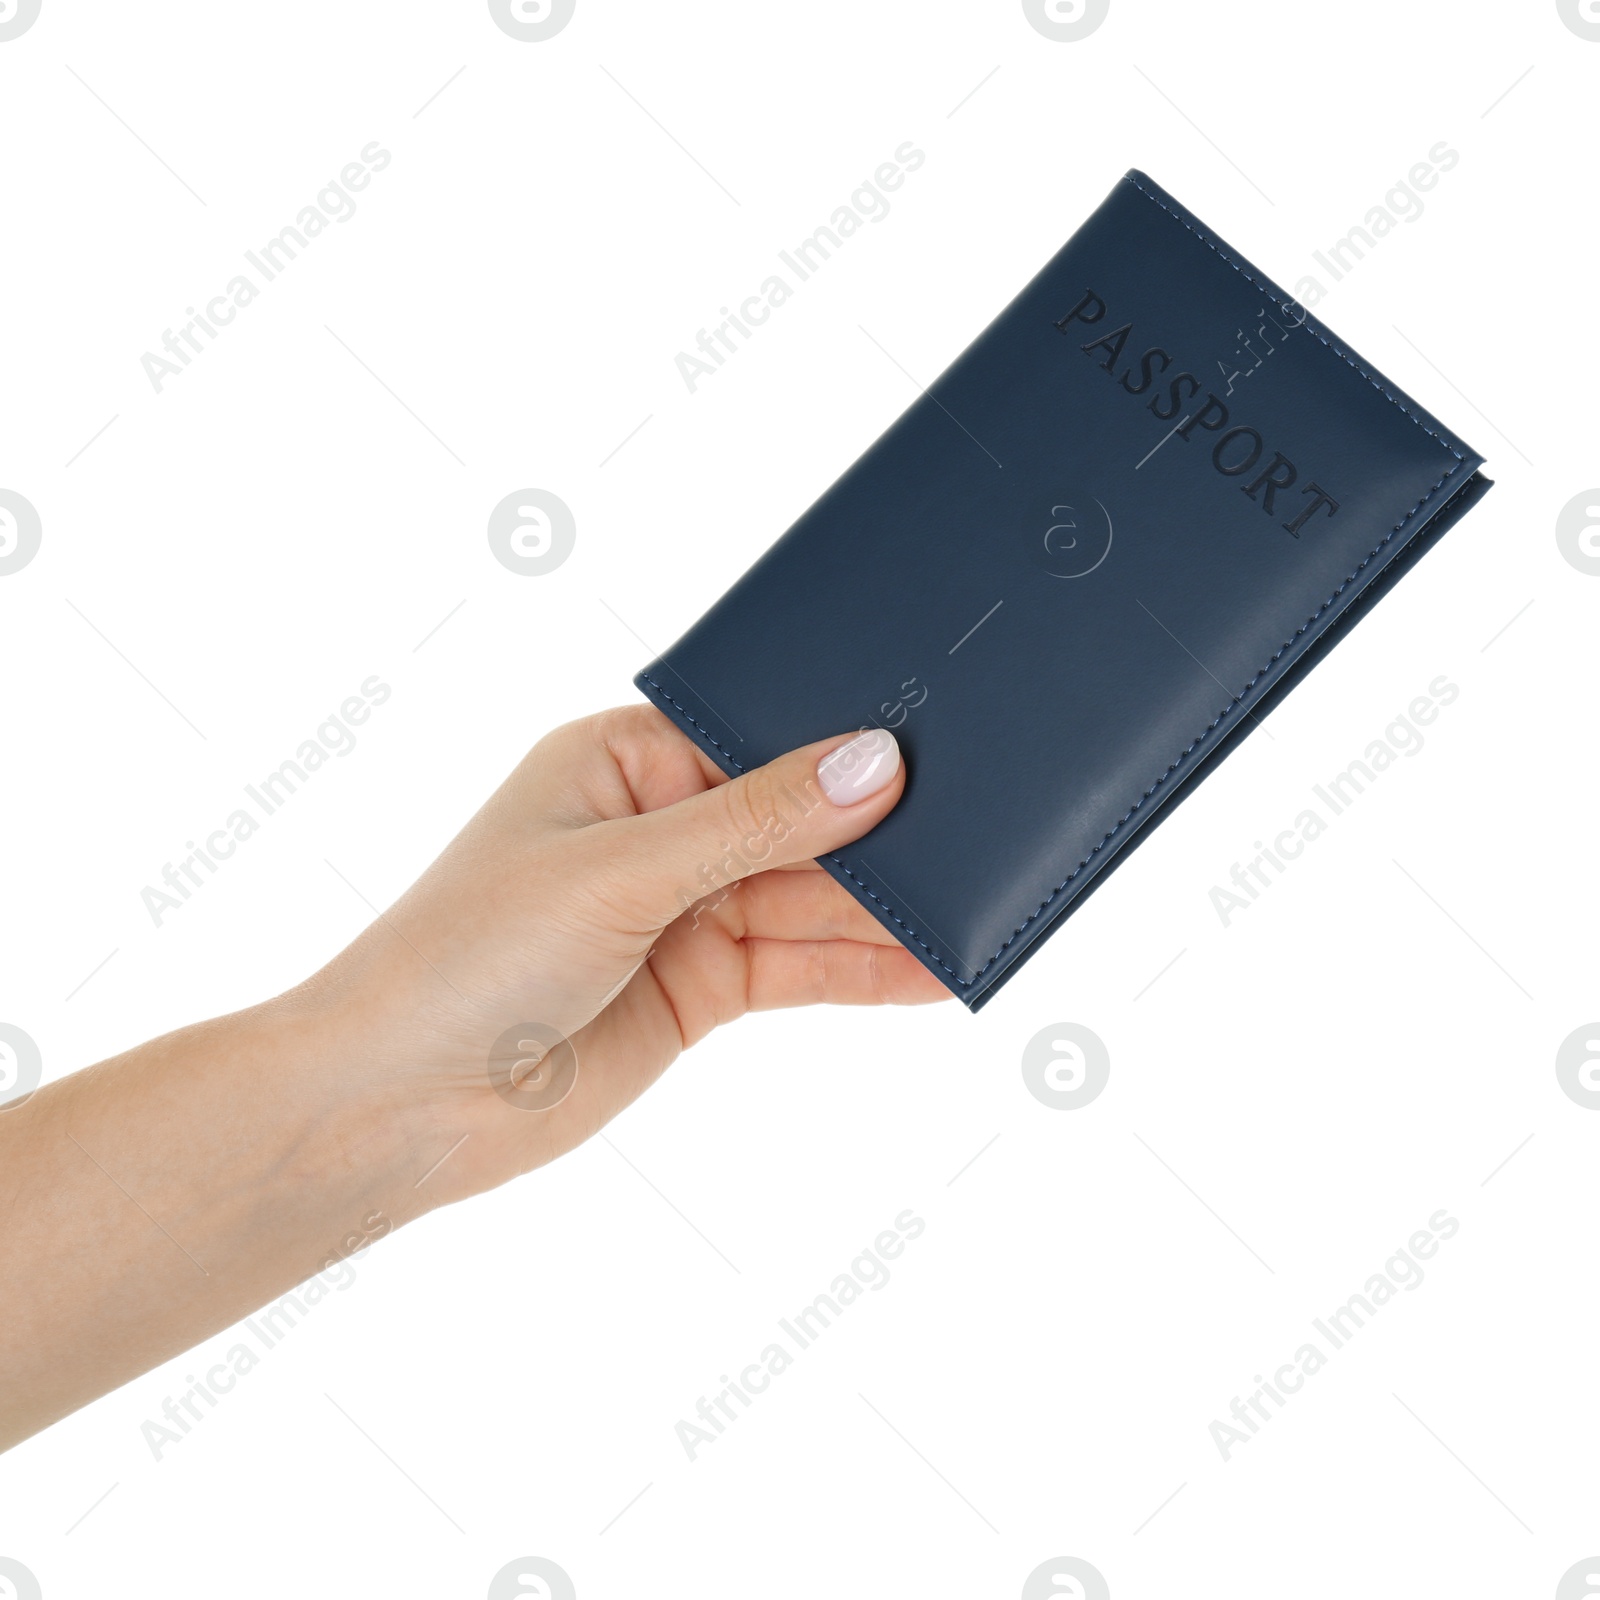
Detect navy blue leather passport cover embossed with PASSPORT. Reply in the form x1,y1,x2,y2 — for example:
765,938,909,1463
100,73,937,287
635,171,1488,1011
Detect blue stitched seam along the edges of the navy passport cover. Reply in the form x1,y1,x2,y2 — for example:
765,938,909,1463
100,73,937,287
640,174,1467,989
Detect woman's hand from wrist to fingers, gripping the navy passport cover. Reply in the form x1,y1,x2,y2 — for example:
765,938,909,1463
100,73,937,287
307,706,949,1203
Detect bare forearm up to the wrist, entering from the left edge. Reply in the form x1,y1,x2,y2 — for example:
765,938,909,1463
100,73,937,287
0,997,428,1448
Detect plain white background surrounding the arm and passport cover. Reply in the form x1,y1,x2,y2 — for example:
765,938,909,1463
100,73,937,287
0,0,1600,1600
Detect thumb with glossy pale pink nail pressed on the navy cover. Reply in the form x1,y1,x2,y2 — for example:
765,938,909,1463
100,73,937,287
614,728,906,926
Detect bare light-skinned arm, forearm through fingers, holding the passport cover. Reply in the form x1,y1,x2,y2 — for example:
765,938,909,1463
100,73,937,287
0,706,949,1450
